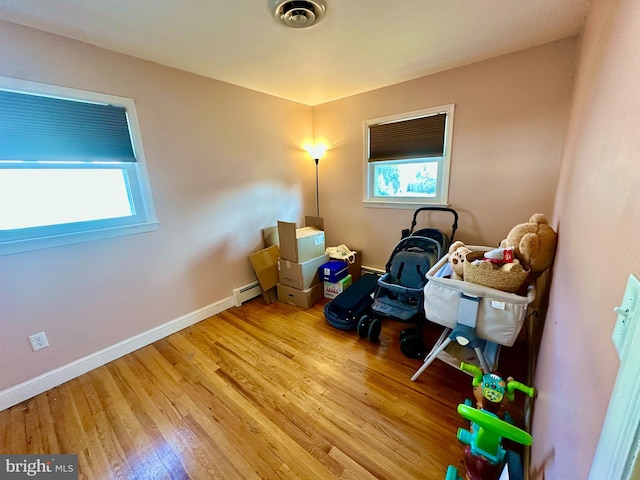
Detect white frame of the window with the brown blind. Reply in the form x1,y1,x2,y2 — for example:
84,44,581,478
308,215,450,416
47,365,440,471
362,103,455,209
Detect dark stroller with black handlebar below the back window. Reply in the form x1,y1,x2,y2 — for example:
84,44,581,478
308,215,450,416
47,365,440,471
357,207,458,352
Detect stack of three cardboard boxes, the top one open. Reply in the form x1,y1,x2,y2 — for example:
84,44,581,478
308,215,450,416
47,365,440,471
277,217,329,308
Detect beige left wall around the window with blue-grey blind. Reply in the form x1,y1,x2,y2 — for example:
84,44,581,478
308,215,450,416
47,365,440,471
0,22,314,391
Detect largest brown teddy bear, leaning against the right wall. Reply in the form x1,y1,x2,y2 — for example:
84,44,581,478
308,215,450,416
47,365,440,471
500,213,558,279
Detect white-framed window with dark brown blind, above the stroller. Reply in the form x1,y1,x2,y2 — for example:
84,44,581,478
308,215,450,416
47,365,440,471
365,104,454,208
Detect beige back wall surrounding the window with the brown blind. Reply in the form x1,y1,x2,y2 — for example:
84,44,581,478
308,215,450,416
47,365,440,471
313,39,576,267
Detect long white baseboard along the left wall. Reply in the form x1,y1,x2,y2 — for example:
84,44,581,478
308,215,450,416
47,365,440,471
0,297,234,411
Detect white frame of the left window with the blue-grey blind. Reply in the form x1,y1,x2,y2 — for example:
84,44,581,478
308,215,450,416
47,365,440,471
0,77,158,255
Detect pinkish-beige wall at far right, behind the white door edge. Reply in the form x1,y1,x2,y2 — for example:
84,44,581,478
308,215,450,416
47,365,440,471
532,0,640,480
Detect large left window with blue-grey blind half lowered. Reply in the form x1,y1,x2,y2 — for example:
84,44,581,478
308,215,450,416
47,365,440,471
0,77,157,255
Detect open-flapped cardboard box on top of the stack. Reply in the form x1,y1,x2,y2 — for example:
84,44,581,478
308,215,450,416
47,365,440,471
278,217,325,263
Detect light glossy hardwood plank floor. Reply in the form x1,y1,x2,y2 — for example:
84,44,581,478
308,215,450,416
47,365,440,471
0,298,522,480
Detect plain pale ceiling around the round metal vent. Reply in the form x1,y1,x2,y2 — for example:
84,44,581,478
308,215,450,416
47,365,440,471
0,0,589,105
